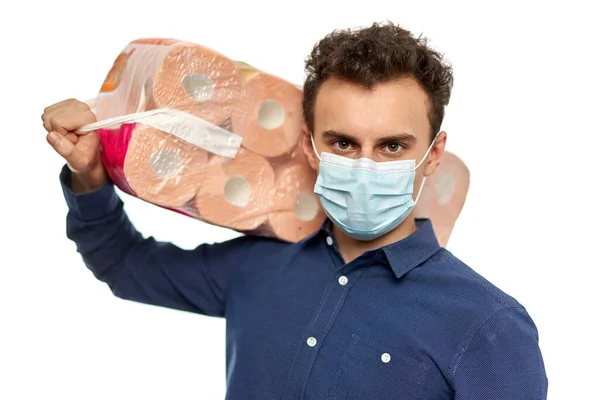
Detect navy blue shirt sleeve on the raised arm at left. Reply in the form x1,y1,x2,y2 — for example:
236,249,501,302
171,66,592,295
60,167,266,317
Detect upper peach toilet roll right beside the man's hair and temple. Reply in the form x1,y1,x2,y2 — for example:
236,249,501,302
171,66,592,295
231,62,303,157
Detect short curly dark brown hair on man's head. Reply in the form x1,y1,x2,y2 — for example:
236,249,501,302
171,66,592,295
302,22,454,139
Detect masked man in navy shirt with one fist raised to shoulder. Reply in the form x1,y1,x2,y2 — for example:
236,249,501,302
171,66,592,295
43,24,547,400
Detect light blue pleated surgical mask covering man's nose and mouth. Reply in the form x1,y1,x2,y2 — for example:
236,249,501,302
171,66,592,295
311,135,437,241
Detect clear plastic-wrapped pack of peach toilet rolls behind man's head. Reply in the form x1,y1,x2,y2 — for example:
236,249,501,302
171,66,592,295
82,39,468,244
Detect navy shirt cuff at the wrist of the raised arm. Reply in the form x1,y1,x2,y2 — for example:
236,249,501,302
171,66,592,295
60,164,121,221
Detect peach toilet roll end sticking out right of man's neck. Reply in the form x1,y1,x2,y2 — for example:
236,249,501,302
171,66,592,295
415,151,470,247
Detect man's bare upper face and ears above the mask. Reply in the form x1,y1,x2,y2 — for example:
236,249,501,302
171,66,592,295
303,78,446,178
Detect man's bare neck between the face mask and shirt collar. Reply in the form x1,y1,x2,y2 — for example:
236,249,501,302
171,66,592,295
333,212,416,263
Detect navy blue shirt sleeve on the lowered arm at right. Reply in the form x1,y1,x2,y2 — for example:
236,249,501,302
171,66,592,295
454,307,548,400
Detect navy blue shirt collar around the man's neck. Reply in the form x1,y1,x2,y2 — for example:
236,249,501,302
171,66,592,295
312,218,441,279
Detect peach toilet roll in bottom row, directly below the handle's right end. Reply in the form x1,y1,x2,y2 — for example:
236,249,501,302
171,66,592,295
195,149,275,231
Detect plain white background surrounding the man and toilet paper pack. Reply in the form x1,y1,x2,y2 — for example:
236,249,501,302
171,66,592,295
0,0,600,400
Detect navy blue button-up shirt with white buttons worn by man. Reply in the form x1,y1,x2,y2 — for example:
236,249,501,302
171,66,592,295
61,168,548,400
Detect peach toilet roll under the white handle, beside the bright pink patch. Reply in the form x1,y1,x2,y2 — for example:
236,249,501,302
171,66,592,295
123,124,208,208
